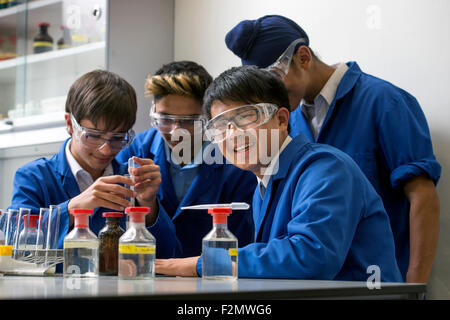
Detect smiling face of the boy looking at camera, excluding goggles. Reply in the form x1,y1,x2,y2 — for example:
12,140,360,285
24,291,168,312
211,100,289,177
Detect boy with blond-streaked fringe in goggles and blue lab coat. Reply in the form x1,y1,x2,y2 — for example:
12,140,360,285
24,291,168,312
117,61,256,257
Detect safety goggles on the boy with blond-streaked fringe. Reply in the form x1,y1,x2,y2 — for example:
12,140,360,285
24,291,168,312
150,103,206,134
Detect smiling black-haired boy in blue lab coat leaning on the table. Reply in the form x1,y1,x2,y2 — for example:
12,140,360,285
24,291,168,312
156,66,402,282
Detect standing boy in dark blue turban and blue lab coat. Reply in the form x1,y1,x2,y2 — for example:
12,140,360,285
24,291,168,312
225,15,441,283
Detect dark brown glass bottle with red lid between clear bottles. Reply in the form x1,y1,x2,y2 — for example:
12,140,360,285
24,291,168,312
98,212,125,276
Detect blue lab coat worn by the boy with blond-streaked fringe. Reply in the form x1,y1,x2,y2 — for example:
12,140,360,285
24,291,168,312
117,128,256,257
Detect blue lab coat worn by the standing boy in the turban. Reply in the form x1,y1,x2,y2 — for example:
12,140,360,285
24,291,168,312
290,62,441,279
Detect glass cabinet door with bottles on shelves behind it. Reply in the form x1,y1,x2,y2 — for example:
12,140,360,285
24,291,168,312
0,0,107,137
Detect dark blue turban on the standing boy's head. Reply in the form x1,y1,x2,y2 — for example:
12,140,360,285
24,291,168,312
225,15,309,68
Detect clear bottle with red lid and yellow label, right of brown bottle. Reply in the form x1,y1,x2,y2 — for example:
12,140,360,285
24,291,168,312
119,207,156,279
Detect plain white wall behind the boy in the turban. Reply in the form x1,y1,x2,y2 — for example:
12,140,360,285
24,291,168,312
175,0,450,299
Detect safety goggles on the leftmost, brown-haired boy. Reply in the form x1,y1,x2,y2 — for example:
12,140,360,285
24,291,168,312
70,114,134,151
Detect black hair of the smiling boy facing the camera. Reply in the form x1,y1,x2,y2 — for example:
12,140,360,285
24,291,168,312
203,66,290,118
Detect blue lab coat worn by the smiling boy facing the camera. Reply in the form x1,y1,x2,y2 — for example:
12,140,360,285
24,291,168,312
197,135,402,282
